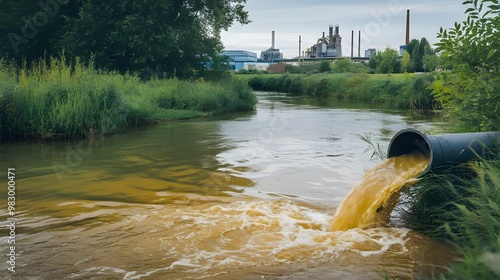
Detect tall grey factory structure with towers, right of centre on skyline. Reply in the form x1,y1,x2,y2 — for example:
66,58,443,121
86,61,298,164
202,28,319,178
305,25,342,58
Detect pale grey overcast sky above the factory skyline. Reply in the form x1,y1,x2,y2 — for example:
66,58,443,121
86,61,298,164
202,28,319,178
221,0,466,58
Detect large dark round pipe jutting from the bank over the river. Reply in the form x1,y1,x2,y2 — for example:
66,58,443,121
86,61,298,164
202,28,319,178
387,129,500,174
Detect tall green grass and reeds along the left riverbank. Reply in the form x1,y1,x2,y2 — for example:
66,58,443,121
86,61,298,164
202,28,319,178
0,59,256,141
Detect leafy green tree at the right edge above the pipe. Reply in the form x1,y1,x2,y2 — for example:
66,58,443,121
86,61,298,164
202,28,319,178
433,0,500,131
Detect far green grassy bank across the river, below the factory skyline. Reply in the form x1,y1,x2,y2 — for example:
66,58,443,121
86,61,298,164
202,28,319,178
235,73,436,109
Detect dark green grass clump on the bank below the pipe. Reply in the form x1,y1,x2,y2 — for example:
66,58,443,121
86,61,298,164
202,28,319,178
402,156,500,279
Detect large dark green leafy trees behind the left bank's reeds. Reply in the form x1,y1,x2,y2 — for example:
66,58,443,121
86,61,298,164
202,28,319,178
0,0,249,78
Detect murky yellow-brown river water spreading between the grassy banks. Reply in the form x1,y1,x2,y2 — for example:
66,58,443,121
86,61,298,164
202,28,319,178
0,95,450,279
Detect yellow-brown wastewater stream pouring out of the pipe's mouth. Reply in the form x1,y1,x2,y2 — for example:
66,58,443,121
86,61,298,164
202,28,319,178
330,154,429,231
